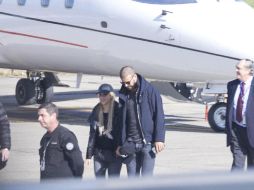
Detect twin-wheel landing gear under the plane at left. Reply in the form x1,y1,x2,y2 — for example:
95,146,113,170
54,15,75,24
15,72,54,105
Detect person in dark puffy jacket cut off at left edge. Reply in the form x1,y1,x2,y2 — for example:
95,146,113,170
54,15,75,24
0,102,11,169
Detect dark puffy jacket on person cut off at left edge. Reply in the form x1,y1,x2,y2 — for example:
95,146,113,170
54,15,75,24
0,103,11,149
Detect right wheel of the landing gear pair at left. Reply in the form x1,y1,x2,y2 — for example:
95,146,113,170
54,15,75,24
37,78,54,104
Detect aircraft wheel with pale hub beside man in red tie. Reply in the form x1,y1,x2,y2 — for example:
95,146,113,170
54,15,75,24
208,102,226,132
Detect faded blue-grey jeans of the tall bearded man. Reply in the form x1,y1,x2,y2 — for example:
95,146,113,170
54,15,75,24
126,144,156,177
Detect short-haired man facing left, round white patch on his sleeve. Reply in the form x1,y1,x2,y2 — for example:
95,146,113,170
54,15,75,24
38,103,84,179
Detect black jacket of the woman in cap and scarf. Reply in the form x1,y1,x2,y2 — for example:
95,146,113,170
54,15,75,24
86,101,119,159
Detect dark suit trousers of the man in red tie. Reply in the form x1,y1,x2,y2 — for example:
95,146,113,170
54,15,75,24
230,123,254,171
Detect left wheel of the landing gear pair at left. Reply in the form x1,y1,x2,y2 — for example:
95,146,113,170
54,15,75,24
15,79,36,105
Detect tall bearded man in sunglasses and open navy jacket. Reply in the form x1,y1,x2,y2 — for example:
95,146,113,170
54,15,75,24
117,66,165,176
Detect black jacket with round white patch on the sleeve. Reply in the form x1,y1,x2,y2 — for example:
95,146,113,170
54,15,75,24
39,125,84,179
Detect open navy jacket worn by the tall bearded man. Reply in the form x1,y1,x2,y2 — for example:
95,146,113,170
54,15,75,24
118,74,165,146
